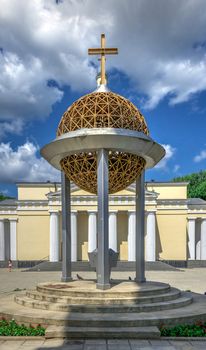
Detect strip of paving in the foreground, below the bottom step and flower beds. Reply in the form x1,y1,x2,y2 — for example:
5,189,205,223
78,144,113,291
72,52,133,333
0,339,206,350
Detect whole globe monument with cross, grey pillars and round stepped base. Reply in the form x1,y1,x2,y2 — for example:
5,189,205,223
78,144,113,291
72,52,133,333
0,35,206,339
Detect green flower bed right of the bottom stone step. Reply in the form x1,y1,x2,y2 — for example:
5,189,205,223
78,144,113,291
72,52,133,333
160,321,206,337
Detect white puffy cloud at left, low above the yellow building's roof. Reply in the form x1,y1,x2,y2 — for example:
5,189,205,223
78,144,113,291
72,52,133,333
0,141,60,183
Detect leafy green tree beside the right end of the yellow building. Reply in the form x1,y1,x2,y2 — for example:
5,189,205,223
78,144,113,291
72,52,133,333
173,170,206,200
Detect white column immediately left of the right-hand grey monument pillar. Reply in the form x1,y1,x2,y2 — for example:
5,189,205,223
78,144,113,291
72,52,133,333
127,211,136,261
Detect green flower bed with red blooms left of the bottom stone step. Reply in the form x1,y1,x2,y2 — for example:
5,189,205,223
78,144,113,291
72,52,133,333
0,319,45,336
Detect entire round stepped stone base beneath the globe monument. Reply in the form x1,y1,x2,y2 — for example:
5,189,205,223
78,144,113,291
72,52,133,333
0,280,206,339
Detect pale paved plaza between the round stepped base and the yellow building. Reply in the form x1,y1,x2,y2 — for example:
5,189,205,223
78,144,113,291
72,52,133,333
0,268,206,294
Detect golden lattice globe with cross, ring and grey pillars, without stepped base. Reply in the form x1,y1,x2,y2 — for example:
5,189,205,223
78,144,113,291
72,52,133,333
41,34,165,290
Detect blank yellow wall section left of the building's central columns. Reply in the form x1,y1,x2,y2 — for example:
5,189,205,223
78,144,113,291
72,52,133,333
17,212,49,260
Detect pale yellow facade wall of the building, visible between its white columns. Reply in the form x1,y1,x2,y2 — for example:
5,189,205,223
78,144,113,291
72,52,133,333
5,182,202,260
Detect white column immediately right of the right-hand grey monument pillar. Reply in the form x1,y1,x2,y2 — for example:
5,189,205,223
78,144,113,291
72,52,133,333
145,211,156,261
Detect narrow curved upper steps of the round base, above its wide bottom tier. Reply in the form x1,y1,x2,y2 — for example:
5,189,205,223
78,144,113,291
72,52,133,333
15,291,192,314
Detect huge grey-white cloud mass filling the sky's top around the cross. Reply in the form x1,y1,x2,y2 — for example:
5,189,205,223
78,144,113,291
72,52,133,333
0,0,206,136
